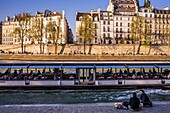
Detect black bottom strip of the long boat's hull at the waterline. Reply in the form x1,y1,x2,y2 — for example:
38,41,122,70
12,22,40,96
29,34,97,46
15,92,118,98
0,84,170,90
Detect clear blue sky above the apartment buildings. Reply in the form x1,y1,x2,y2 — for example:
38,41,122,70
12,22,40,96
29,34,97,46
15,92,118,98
0,0,170,36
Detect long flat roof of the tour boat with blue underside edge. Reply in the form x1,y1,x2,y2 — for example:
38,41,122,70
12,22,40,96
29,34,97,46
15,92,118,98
0,62,170,69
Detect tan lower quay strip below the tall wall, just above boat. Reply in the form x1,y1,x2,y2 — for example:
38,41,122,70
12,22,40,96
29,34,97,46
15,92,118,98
0,54,170,62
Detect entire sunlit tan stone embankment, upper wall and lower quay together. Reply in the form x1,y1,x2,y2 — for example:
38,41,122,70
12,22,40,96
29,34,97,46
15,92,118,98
0,44,170,62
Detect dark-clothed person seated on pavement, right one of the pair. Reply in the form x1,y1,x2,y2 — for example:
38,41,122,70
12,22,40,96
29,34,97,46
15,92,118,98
140,90,152,107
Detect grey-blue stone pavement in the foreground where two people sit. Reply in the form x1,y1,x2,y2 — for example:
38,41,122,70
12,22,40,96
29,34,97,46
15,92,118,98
0,102,170,113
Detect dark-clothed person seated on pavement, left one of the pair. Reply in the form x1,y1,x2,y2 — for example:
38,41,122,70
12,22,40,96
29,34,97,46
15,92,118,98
129,92,141,111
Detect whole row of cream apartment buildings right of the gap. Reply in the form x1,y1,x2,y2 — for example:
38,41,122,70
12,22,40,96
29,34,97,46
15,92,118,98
76,0,170,44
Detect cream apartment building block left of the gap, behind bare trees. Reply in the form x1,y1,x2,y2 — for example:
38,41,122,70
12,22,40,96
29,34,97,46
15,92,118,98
2,10,73,44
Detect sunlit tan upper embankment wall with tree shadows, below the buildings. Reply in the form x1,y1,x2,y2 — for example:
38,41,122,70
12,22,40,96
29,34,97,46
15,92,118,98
0,44,170,55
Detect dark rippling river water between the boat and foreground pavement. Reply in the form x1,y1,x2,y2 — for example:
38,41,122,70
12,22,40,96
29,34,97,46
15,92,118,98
0,89,170,105
